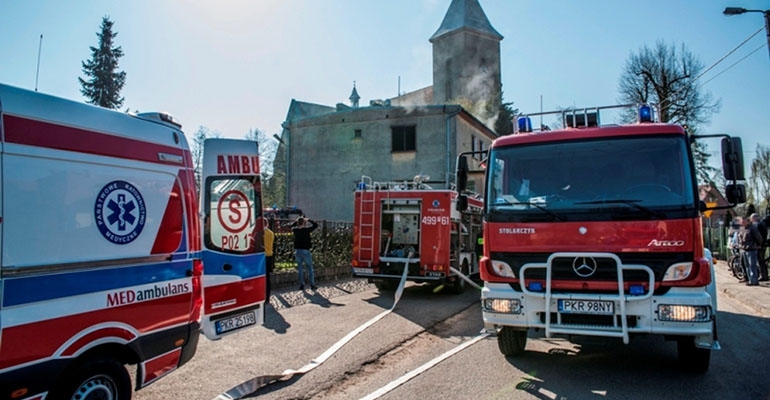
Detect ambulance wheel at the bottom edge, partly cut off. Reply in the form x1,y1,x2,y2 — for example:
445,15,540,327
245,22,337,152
50,359,131,400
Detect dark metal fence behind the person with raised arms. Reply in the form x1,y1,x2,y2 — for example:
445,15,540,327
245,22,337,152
272,219,353,270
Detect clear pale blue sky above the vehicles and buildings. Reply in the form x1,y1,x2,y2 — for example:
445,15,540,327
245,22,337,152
0,0,770,173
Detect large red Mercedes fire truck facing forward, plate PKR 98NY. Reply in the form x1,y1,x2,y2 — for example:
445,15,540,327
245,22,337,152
457,106,746,373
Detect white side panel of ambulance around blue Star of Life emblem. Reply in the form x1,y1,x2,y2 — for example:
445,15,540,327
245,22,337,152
2,144,178,268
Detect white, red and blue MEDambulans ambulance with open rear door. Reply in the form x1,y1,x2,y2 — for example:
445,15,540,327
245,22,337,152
0,84,265,400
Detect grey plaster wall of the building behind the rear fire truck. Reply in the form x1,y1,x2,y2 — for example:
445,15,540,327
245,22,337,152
285,106,491,221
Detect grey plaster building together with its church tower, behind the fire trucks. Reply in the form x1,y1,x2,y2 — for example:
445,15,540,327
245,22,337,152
273,0,503,221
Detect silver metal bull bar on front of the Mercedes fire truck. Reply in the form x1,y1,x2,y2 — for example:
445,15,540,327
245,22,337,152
520,252,655,344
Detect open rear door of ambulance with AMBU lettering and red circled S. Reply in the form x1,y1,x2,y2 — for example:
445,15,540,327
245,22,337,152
200,139,265,340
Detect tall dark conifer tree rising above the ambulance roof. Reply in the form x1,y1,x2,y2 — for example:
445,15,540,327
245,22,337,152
78,16,126,109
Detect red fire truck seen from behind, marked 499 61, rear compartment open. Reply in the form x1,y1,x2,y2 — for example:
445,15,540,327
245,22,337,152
353,176,482,293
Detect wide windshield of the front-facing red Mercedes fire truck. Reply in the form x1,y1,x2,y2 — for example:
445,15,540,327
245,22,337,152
485,135,697,221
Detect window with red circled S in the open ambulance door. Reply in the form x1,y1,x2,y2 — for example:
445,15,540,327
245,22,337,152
204,177,262,253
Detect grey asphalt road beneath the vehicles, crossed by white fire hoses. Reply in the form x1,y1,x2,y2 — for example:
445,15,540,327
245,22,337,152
134,274,770,400
